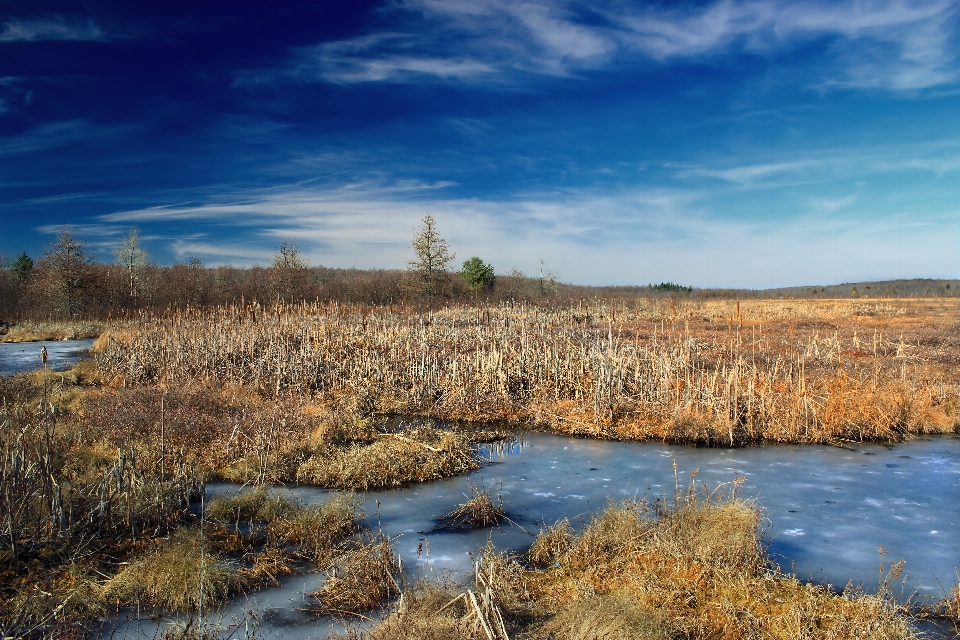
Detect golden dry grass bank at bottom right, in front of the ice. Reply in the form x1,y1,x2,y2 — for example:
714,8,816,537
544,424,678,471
356,482,920,640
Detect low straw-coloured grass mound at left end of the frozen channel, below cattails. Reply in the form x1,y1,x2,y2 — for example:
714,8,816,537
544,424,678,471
297,430,480,491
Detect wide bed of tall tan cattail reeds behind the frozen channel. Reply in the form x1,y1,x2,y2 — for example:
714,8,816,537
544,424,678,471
96,299,960,446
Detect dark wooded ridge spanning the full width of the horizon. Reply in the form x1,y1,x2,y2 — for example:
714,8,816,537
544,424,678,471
0,233,960,322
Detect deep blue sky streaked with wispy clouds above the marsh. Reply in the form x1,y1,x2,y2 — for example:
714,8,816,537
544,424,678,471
0,0,960,287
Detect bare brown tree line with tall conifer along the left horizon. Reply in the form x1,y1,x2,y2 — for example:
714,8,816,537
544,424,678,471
0,214,568,321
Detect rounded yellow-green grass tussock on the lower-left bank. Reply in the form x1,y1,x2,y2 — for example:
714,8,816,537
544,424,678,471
104,530,243,611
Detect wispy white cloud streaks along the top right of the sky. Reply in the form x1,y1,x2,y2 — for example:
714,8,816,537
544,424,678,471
259,0,960,91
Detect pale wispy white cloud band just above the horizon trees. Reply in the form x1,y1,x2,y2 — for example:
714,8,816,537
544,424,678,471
78,171,960,287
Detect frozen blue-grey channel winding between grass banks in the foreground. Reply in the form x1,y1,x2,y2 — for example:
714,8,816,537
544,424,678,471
105,433,960,638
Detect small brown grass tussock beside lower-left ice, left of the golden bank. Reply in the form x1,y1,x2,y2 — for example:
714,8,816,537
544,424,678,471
310,538,400,616
